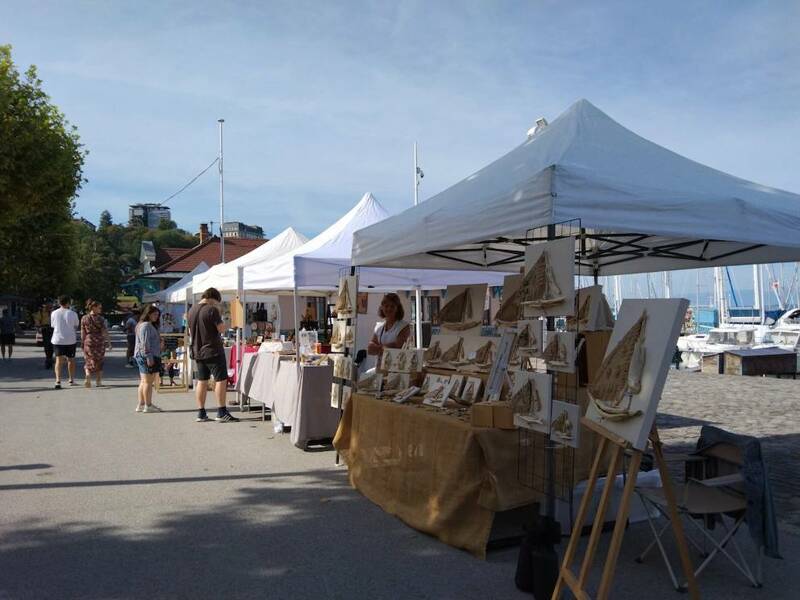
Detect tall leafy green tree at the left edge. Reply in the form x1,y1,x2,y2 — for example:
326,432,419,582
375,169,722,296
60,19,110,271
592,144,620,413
0,46,87,297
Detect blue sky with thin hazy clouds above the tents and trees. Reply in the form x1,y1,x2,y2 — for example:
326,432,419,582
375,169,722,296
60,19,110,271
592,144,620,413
0,0,800,304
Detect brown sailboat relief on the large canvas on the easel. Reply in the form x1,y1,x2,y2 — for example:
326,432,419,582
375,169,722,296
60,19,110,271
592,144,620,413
589,311,647,421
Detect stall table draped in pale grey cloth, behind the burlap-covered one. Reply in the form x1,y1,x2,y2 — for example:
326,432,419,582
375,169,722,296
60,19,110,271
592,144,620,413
237,352,339,448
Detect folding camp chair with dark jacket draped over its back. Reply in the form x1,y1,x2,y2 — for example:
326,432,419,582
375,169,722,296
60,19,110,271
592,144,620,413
636,443,762,591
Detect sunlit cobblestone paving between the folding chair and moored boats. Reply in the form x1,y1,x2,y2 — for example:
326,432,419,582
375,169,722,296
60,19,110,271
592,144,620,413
657,371,800,533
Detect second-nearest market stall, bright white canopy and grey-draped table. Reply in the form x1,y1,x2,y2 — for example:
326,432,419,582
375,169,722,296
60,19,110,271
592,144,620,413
239,193,510,447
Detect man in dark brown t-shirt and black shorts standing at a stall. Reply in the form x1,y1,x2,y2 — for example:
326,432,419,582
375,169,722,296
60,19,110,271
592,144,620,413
187,288,239,423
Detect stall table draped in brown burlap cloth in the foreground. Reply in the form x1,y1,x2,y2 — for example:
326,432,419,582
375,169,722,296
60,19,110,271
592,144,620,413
334,394,594,557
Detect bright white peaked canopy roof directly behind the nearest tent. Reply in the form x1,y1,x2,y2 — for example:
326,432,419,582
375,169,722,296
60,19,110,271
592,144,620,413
244,193,506,293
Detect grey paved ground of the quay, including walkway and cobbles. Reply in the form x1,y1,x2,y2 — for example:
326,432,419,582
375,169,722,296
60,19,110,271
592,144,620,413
0,338,800,600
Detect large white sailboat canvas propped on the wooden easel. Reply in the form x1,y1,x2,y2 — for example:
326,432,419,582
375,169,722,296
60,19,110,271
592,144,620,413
586,298,689,450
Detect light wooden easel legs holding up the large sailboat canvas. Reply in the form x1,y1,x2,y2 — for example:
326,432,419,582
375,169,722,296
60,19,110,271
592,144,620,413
552,417,700,600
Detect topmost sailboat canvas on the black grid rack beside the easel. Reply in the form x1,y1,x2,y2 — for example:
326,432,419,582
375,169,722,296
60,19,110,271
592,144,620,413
519,237,575,318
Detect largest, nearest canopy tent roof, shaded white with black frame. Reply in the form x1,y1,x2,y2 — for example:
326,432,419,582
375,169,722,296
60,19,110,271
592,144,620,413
352,100,800,276
